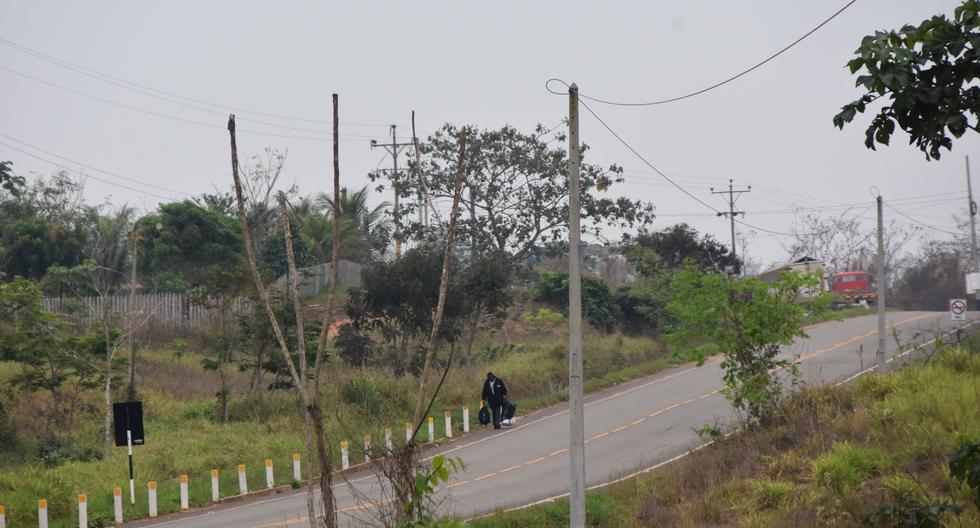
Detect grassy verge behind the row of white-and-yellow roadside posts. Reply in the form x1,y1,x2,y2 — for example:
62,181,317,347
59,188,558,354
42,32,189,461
0,330,704,527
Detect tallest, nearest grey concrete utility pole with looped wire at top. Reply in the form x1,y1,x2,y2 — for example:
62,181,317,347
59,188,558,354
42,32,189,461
568,83,585,528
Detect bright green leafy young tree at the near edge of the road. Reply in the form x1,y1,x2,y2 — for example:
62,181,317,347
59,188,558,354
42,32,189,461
668,266,827,419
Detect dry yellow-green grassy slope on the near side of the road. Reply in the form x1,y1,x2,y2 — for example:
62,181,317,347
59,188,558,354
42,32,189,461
473,336,980,528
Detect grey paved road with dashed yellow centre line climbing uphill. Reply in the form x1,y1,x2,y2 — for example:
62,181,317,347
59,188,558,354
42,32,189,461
133,312,972,528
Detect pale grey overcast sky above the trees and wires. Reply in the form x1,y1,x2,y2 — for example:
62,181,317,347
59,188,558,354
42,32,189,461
0,0,980,263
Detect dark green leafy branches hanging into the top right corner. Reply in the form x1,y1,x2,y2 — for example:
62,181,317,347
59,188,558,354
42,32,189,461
834,0,980,159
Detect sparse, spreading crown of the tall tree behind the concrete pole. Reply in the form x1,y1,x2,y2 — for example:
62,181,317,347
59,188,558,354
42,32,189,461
369,124,653,262
